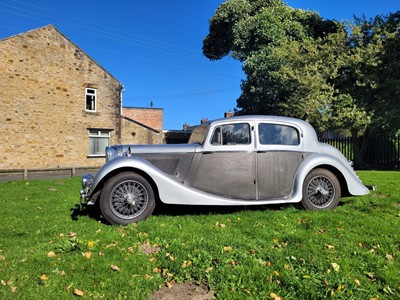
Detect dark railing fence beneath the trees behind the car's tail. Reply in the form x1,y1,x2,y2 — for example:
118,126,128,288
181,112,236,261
319,136,400,168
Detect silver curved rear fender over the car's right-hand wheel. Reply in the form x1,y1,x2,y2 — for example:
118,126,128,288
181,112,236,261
293,154,369,198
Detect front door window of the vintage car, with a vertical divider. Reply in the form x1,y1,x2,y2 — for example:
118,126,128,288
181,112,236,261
211,123,251,146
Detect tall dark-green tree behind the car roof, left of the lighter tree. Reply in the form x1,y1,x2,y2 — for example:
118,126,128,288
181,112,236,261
203,0,341,117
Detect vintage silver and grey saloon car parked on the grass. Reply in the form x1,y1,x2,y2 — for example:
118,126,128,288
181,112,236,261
81,116,369,224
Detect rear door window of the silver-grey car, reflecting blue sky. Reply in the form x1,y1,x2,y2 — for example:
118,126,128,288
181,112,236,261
258,123,300,146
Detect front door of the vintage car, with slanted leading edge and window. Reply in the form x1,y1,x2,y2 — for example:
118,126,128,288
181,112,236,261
192,122,256,200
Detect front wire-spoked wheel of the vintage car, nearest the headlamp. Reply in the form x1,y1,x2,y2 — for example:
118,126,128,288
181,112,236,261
100,172,155,225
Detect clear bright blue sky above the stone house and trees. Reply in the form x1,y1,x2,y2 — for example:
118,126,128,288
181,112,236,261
0,0,400,129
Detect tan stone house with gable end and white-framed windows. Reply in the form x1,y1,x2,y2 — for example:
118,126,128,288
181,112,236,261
0,25,163,170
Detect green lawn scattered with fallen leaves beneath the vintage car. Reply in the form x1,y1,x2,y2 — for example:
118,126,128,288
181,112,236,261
0,171,400,299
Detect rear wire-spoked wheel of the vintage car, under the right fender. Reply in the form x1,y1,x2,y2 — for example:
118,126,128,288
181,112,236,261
301,169,341,210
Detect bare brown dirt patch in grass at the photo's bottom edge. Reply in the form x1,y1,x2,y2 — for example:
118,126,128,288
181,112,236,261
150,282,215,300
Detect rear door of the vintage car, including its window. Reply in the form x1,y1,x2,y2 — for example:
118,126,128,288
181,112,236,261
256,122,303,200
